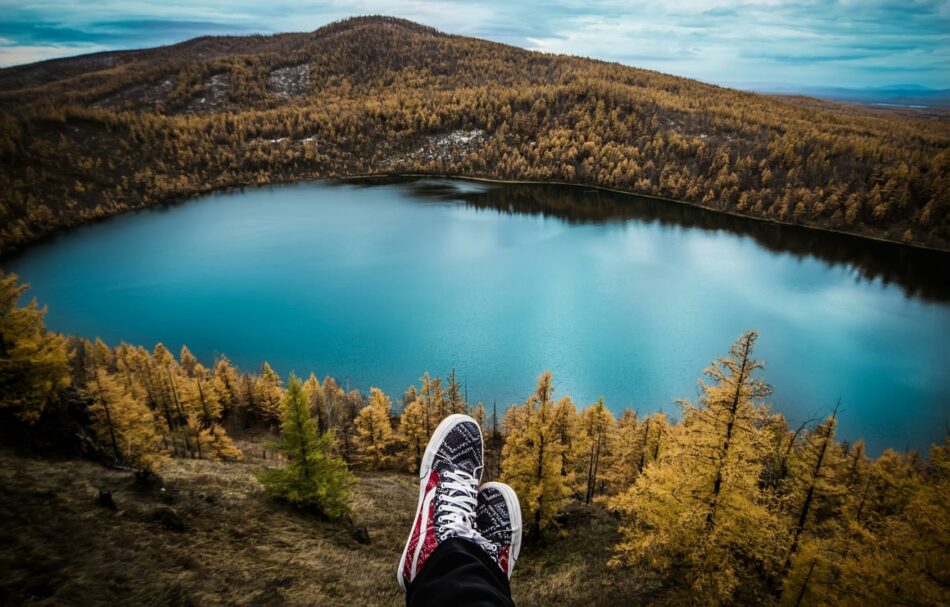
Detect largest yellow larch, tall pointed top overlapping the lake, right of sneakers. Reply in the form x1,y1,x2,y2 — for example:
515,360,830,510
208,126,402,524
611,332,781,604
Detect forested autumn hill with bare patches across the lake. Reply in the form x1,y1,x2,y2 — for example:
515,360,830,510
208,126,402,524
0,17,950,250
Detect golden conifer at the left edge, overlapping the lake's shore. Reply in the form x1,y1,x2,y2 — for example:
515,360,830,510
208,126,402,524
0,274,70,422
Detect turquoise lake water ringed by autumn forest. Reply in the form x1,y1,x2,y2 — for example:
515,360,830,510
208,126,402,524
4,181,950,451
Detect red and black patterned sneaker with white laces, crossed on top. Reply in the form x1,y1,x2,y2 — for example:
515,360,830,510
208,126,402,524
396,414,490,591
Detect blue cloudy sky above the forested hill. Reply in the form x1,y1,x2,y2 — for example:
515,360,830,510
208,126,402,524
0,0,950,88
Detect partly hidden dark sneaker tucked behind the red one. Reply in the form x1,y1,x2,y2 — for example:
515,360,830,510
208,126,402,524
475,483,521,579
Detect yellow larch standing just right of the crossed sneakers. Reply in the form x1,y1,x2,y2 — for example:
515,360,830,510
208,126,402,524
501,371,571,537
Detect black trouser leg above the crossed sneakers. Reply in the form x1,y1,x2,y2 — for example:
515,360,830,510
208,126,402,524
406,538,515,607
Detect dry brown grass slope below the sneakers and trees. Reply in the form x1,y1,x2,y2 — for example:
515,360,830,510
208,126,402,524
0,442,655,607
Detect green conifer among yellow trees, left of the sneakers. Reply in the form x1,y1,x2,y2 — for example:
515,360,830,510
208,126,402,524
258,376,353,518
